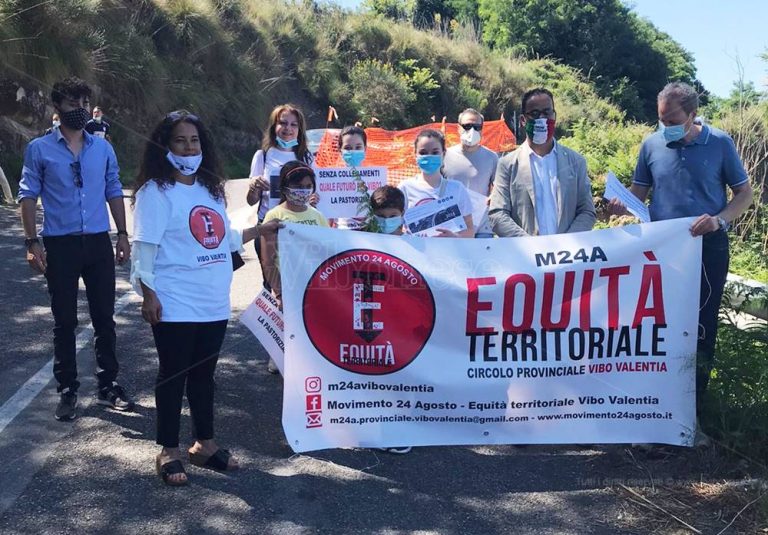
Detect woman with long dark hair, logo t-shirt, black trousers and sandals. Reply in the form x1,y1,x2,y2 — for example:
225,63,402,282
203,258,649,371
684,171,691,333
131,111,280,486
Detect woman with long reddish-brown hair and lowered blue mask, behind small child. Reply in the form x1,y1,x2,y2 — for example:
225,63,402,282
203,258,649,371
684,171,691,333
246,104,320,290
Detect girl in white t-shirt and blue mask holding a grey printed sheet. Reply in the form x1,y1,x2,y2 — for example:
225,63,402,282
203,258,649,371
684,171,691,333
398,128,475,238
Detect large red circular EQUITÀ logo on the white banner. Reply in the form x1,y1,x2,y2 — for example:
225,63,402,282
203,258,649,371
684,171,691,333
303,249,435,375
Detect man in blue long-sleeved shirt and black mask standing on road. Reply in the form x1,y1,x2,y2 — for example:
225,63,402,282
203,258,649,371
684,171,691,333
19,78,133,421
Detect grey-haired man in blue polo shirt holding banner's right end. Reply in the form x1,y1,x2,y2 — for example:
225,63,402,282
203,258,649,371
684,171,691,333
612,82,752,442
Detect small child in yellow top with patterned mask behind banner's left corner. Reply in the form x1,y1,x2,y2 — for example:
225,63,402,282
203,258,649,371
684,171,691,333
261,161,329,316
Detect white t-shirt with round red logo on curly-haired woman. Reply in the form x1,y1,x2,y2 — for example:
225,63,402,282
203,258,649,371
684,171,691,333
133,180,232,322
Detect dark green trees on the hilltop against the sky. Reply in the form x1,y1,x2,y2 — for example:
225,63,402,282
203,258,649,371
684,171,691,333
367,0,697,120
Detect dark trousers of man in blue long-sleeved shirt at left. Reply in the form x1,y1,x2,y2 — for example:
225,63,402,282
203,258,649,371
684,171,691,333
43,232,118,392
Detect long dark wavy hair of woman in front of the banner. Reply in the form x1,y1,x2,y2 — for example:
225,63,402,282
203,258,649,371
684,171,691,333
131,110,225,205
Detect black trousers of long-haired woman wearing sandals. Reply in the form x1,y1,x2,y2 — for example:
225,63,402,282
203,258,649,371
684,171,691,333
152,320,227,448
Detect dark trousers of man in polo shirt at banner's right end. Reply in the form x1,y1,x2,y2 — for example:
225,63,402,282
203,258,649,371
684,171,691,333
696,230,730,412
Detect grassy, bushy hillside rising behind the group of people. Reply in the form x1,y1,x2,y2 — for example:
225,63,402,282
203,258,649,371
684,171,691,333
0,0,623,182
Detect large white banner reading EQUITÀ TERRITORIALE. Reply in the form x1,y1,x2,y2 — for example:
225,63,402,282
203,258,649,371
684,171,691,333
278,219,701,452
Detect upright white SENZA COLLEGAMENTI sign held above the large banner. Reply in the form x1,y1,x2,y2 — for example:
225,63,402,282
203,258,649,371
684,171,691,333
316,167,387,219
